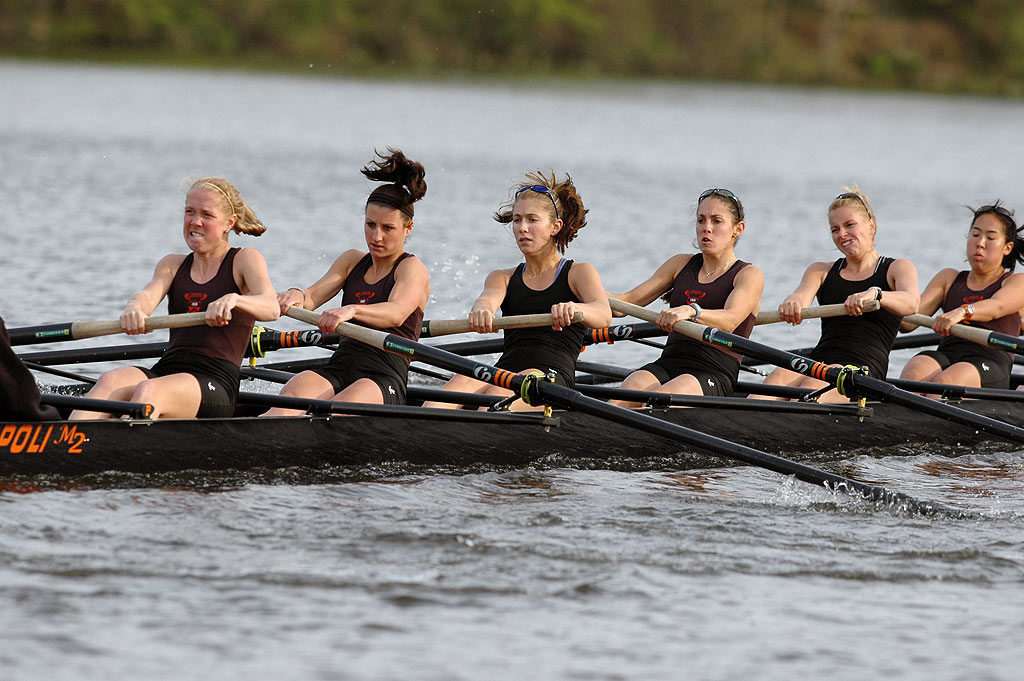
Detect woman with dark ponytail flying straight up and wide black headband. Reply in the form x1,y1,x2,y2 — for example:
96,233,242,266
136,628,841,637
263,148,430,416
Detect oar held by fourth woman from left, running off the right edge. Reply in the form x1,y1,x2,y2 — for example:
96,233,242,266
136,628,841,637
608,299,1024,443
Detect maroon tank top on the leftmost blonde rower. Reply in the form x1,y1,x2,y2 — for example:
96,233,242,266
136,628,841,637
167,248,256,365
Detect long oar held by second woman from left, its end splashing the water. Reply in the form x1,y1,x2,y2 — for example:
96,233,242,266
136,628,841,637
287,307,963,516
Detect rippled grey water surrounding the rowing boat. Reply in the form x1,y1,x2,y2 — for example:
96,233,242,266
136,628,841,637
0,62,1024,679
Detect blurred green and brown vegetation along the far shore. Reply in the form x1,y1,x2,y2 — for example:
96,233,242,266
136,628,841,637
0,0,1024,97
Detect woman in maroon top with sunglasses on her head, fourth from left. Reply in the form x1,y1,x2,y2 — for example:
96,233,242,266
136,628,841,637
612,188,765,407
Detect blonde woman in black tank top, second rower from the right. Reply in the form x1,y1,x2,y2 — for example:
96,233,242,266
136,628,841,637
756,184,921,401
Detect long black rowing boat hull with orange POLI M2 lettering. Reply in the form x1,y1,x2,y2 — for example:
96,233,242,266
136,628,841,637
0,386,1024,478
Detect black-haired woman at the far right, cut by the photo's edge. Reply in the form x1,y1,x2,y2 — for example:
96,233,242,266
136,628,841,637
900,201,1024,388
